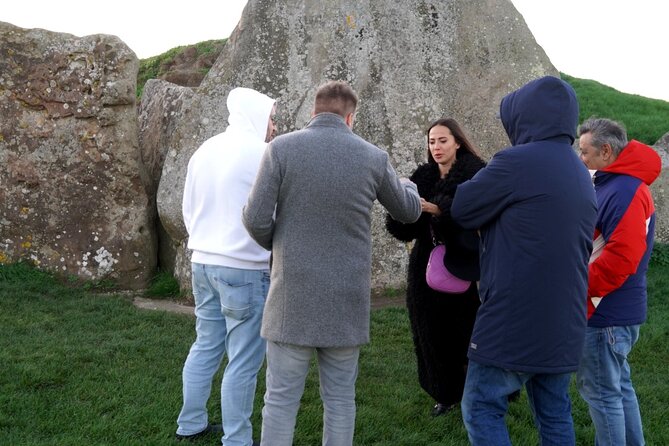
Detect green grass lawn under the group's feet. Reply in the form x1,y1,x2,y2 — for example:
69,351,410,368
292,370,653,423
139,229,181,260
0,253,669,446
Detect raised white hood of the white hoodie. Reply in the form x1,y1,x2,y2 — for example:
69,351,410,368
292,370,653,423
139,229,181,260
227,87,276,141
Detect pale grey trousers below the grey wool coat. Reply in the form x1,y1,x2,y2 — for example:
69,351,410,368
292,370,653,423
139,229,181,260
260,341,360,446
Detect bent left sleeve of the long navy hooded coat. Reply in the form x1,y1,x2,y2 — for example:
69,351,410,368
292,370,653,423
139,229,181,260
451,149,516,229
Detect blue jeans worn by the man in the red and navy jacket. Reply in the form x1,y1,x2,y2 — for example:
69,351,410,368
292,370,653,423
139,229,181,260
576,325,645,446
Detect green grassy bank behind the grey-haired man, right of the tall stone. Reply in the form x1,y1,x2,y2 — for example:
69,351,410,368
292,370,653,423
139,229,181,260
560,73,669,145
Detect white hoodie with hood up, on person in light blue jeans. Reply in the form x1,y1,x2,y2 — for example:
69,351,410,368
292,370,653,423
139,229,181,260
182,88,275,270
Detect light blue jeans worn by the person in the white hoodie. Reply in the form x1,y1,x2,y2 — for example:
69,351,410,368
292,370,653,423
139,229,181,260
177,263,269,446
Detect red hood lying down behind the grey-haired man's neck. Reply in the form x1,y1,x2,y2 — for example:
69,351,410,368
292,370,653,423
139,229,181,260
600,139,662,186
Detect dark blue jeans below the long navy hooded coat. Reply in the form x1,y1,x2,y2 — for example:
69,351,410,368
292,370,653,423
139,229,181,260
461,360,576,446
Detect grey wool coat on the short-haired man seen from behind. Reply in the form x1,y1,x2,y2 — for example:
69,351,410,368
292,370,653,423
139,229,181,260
242,113,421,347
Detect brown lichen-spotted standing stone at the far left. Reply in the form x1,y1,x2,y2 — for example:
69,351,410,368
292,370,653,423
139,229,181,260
0,22,156,288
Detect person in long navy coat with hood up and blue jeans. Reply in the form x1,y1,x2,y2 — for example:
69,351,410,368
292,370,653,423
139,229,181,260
451,77,597,446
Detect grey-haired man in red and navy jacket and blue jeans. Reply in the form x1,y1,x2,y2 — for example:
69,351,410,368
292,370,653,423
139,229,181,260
577,118,662,446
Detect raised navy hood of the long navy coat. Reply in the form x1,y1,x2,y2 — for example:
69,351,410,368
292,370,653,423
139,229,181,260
500,76,578,145
